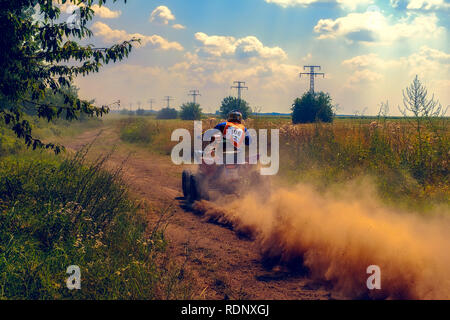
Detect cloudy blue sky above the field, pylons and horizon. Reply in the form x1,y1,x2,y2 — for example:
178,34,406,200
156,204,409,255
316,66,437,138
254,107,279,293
60,0,450,114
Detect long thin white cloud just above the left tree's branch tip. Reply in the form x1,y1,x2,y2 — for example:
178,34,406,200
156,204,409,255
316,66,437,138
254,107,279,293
92,22,184,51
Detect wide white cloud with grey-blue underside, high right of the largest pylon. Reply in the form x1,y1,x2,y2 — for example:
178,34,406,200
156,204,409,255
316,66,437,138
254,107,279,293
314,11,445,45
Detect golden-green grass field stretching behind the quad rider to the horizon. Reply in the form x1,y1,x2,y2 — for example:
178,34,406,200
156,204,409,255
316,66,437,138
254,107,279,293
117,116,450,211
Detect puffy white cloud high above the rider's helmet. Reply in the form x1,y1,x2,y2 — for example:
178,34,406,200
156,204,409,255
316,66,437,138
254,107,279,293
195,32,287,60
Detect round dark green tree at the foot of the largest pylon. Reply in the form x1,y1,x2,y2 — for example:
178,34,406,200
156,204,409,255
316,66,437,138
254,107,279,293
291,92,334,124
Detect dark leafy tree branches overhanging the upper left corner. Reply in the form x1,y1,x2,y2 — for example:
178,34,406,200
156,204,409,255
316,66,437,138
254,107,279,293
0,0,139,153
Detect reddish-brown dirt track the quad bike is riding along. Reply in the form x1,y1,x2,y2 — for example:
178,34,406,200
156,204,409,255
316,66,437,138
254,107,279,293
65,127,333,300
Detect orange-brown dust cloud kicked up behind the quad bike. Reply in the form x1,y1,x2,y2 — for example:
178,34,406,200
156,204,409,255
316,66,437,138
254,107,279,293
195,183,450,299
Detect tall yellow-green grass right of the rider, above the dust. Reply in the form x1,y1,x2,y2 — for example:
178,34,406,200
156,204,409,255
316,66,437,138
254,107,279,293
280,119,450,206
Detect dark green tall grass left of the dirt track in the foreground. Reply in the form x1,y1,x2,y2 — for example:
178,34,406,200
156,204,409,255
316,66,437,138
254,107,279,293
0,149,190,299
